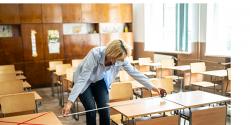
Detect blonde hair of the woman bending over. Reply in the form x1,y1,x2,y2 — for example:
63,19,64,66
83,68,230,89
105,40,131,60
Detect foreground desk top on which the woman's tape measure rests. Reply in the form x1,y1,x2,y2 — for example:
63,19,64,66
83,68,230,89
110,97,183,118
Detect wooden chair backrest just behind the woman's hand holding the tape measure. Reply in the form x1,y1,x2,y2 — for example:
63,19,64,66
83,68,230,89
150,78,174,94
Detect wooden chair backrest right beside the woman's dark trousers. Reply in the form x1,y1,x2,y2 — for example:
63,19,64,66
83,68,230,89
109,82,133,101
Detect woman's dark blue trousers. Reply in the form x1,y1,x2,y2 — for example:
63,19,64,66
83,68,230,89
79,80,110,125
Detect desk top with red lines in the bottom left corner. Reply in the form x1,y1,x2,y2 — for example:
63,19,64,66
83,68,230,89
0,112,62,125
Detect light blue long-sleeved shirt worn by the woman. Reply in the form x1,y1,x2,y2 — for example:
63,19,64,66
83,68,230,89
68,47,153,102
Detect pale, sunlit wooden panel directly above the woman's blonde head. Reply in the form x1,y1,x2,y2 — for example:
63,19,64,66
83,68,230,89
101,32,134,49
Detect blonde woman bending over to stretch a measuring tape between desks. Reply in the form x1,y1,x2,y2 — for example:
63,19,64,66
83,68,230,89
63,40,159,125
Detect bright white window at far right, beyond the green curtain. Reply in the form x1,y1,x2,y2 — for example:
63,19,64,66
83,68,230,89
205,3,233,57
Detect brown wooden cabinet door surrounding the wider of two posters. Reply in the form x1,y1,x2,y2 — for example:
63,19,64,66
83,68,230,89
43,24,64,60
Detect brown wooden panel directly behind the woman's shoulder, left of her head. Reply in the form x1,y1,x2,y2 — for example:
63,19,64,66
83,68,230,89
64,34,100,59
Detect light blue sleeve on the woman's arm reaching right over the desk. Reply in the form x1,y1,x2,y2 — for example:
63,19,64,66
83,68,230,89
123,61,154,90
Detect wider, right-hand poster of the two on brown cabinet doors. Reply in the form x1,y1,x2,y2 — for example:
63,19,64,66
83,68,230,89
48,30,60,54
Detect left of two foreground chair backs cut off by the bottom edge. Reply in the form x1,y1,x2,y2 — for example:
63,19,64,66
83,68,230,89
135,115,180,125
